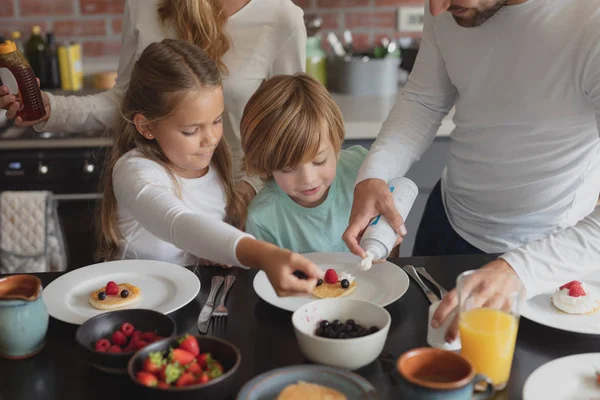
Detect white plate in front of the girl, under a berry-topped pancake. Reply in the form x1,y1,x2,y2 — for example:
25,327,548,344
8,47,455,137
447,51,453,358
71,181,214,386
42,260,200,324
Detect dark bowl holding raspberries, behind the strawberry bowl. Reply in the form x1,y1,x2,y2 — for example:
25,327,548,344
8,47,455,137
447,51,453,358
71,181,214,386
75,309,177,374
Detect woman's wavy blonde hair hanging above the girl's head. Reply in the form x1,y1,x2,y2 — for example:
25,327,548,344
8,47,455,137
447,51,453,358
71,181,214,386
158,0,230,73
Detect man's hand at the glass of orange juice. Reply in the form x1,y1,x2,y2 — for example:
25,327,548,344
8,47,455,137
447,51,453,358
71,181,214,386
431,258,523,343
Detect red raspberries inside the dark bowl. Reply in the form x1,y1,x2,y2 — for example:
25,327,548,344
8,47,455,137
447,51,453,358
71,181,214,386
94,322,164,353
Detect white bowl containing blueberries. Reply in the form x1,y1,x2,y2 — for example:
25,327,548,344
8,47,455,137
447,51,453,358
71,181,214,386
292,298,392,370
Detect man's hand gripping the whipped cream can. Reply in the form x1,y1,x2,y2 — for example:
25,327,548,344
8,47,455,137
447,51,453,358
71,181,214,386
342,179,407,258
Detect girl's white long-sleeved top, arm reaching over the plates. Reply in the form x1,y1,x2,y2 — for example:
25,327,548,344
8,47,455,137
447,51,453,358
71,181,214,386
112,150,252,266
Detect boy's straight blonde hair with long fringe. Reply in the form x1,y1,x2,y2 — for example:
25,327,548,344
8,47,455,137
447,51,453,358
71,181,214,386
240,73,344,179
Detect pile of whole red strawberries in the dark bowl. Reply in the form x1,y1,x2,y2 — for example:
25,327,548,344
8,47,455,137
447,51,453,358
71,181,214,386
136,335,223,388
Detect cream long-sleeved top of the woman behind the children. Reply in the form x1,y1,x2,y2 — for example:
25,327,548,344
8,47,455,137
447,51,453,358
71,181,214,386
35,0,306,189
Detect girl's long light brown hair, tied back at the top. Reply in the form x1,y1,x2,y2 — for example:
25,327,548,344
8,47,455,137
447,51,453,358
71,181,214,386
96,39,245,261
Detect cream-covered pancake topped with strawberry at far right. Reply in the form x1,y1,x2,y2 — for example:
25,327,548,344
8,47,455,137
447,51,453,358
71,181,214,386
550,281,600,314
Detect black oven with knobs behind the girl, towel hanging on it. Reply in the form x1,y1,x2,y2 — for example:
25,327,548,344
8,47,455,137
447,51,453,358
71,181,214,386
0,123,111,269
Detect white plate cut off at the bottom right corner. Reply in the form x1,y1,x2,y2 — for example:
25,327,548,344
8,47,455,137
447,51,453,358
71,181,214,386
523,353,600,400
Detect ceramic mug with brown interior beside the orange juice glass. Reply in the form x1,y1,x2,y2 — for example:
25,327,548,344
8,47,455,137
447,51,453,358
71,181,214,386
396,347,495,400
